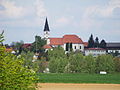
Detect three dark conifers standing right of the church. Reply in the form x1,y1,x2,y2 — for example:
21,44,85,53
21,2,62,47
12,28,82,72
88,34,106,48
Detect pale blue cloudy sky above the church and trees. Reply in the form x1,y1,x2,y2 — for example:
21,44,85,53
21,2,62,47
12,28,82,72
0,0,120,44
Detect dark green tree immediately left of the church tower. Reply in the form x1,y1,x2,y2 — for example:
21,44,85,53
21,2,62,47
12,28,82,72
31,36,46,52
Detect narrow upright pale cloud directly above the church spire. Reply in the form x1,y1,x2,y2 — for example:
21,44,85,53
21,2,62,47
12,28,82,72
35,0,47,18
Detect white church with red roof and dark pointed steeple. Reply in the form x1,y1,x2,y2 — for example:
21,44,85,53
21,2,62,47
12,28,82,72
44,18,86,52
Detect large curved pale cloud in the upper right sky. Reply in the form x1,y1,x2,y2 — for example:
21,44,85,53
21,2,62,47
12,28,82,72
80,0,120,30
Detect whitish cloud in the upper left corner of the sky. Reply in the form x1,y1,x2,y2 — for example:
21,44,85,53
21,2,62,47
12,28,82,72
0,0,26,18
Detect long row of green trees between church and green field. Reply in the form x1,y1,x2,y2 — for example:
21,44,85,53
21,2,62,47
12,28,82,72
48,47,120,73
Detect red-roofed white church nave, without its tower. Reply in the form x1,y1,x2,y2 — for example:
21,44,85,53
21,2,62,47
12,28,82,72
47,35,84,52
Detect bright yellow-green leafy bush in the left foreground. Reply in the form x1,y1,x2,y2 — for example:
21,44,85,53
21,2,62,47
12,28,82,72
0,47,36,90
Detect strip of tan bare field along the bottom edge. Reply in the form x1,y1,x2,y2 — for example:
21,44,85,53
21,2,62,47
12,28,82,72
38,83,120,90
